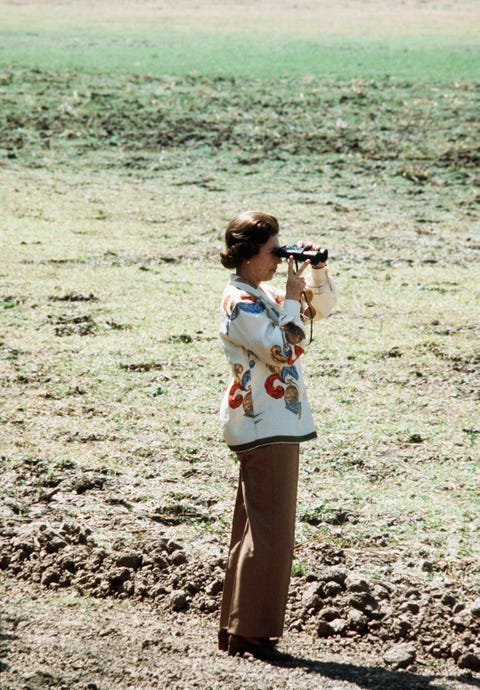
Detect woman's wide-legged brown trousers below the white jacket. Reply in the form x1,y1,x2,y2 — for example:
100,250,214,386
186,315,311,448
220,443,299,637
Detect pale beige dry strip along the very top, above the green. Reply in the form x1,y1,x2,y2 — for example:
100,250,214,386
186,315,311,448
0,0,479,39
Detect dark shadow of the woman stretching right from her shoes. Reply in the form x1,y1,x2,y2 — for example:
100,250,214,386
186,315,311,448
269,656,480,690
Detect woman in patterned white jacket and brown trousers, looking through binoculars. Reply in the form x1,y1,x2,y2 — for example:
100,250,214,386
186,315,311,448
218,211,336,660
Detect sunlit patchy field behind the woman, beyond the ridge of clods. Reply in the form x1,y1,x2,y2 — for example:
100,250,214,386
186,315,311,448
0,2,480,684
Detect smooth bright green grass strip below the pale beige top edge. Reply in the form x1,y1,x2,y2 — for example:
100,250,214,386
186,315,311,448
0,30,480,82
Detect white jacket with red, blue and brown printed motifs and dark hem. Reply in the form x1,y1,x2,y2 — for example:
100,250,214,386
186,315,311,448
220,268,337,453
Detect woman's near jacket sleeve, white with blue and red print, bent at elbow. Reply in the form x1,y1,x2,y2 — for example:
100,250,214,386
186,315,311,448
222,296,306,367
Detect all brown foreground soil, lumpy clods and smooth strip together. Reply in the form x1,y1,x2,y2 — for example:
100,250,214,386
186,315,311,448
0,462,480,690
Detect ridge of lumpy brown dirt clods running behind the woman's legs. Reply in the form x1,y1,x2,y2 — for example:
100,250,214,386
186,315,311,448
0,521,480,671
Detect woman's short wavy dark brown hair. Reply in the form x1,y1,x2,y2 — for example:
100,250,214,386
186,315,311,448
220,211,279,268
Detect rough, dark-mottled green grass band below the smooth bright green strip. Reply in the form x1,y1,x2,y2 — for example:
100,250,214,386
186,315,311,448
0,70,479,188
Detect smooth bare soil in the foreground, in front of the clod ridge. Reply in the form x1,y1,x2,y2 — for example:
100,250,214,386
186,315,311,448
0,585,479,690
